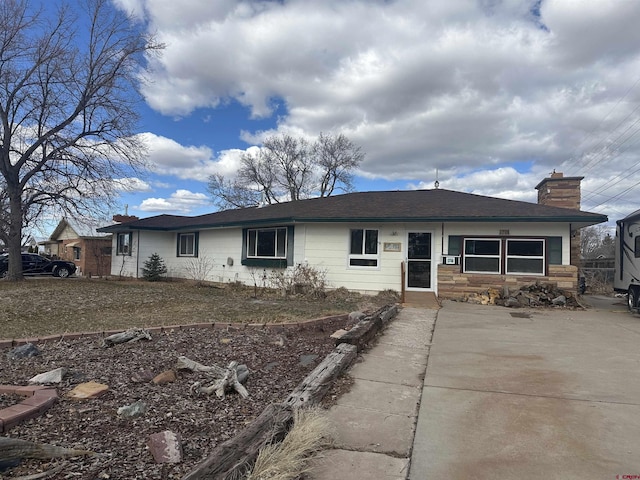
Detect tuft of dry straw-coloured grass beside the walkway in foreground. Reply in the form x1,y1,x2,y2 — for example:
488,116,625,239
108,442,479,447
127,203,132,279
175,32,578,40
245,409,331,480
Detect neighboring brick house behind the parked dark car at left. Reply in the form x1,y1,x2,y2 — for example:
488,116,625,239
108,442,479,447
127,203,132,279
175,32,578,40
40,218,111,276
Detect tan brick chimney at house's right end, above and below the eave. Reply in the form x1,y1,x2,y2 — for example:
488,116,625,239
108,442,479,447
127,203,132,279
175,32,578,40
536,170,584,276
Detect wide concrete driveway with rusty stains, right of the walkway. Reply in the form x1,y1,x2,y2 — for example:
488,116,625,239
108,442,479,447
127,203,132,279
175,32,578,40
409,297,640,480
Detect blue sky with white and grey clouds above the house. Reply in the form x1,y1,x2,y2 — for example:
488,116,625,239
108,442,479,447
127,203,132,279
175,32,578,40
100,0,640,227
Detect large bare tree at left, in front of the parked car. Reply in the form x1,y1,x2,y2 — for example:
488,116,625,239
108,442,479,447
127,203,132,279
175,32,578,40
0,0,161,280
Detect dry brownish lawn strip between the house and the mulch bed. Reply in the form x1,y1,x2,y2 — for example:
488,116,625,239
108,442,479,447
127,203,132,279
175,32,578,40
0,278,397,339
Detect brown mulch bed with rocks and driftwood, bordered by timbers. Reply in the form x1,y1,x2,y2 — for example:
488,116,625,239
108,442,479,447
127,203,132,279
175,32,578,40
0,320,356,480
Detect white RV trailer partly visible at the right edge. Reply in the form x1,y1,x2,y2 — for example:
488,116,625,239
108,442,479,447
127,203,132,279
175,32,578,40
613,210,640,312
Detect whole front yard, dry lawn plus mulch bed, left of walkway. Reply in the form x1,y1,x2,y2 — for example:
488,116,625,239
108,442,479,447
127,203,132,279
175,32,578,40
0,279,397,480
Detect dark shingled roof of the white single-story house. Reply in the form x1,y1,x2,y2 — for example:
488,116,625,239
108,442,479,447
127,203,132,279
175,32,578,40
99,189,607,232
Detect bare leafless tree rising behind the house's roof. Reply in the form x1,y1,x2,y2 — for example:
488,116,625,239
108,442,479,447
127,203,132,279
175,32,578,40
208,133,364,209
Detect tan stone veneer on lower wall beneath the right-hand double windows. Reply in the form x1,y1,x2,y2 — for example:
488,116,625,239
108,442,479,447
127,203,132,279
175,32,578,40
438,265,578,300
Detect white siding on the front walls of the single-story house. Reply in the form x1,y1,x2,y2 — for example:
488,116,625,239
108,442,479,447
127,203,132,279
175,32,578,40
111,222,570,292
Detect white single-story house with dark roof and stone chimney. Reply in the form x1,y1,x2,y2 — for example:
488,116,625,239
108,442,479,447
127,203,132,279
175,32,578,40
99,173,607,298
